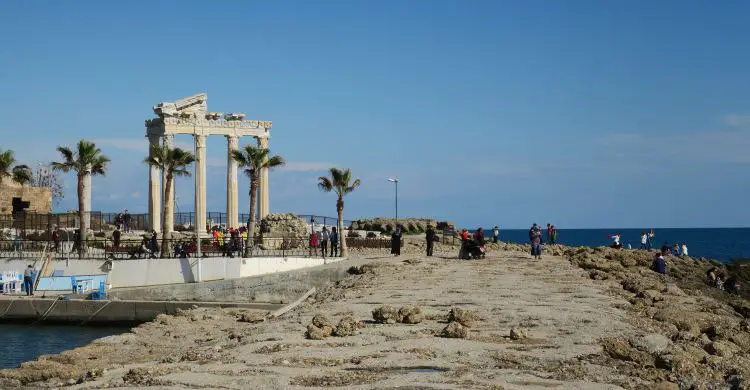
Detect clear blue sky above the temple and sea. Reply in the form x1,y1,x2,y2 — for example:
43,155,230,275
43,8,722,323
0,0,750,228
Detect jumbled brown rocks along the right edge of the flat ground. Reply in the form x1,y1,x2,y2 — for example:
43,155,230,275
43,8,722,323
560,247,750,389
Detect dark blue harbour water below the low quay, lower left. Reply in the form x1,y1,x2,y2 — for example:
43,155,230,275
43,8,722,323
0,324,130,368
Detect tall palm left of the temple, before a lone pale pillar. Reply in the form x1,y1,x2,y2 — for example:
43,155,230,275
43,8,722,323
51,140,110,258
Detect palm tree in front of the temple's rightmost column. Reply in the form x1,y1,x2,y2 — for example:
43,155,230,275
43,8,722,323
232,145,286,256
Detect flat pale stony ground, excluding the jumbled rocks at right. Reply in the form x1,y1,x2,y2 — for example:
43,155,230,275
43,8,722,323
1,252,648,389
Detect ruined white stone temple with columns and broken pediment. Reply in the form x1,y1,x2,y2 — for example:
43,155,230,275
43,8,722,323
146,93,271,232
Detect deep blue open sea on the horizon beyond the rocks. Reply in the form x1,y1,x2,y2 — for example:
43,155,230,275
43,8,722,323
485,226,750,263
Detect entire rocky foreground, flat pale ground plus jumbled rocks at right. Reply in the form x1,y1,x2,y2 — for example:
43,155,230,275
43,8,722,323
0,237,750,389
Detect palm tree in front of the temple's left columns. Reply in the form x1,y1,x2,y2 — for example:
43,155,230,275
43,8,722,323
143,145,195,257
